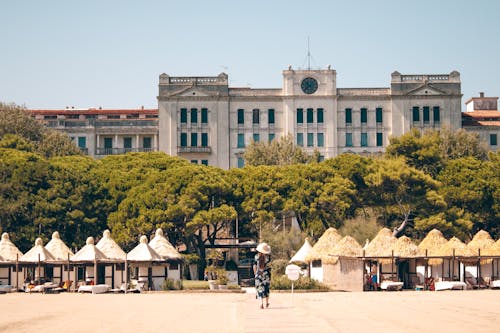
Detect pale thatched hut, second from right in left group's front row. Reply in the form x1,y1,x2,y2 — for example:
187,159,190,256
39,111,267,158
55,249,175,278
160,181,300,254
70,237,107,287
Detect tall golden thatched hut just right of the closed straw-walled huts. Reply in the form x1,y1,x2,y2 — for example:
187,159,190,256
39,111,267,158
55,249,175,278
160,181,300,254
364,228,397,284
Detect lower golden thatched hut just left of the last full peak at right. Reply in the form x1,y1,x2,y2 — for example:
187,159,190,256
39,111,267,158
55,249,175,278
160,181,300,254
429,237,477,282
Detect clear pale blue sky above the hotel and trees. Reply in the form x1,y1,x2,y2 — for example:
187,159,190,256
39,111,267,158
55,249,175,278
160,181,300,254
0,0,500,109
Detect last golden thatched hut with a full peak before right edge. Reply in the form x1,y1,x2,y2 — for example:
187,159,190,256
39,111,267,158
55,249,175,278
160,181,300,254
465,230,495,285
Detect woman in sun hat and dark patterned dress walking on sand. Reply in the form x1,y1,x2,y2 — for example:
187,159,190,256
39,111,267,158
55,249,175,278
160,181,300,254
253,243,271,309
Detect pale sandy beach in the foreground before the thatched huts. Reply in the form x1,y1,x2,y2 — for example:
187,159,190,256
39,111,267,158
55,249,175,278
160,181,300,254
0,290,500,333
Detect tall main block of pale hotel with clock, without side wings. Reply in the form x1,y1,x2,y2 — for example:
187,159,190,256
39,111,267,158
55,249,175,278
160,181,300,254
158,68,462,169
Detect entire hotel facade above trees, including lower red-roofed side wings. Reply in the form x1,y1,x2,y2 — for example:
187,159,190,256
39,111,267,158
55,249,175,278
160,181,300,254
31,67,500,169
